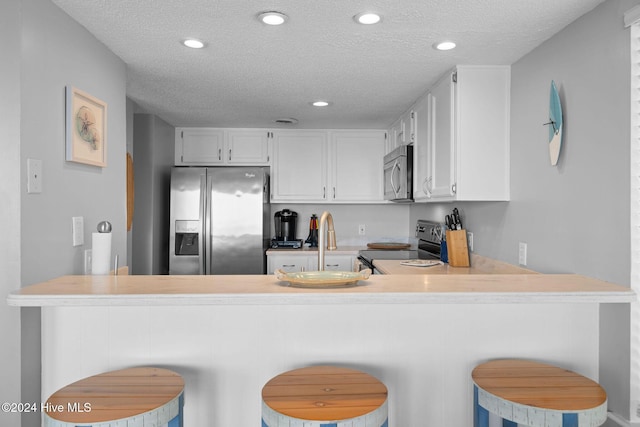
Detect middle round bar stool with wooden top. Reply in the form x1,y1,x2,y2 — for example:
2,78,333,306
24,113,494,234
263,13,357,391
262,366,388,427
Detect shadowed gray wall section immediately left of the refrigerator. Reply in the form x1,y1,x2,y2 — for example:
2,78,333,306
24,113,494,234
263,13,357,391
131,114,175,274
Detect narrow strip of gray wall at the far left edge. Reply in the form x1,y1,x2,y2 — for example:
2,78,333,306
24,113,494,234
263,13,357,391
0,0,21,426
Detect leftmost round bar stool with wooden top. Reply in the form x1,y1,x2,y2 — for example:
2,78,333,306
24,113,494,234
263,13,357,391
42,367,184,427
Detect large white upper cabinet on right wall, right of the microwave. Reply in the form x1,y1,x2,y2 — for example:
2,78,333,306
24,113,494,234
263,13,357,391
413,66,510,201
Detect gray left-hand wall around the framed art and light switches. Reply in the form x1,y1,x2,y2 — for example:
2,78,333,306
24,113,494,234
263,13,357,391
11,0,127,426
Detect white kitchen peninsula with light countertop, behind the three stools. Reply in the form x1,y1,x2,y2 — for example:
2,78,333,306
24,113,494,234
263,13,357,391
8,274,636,426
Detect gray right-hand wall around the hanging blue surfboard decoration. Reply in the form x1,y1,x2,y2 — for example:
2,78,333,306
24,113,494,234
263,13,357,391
411,0,639,419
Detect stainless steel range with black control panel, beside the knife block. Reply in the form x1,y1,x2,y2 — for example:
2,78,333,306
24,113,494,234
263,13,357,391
358,219,442,274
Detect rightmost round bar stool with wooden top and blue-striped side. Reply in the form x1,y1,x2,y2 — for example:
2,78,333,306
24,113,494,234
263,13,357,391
471,359,607,427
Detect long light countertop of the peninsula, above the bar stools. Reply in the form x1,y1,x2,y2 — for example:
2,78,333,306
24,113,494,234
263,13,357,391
7,274,636,307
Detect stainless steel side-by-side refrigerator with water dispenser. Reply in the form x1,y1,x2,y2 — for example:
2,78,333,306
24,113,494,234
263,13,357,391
169,167,271,274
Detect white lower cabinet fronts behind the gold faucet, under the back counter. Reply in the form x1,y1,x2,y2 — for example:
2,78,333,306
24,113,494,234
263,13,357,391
267,251,356,274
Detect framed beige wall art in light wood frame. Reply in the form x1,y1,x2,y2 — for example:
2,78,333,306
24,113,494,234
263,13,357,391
65,86,107,167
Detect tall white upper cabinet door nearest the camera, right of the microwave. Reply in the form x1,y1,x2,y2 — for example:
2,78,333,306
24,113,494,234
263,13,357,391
427,74,456,199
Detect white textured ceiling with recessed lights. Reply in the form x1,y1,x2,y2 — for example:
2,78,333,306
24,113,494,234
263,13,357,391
52,0,604,128
